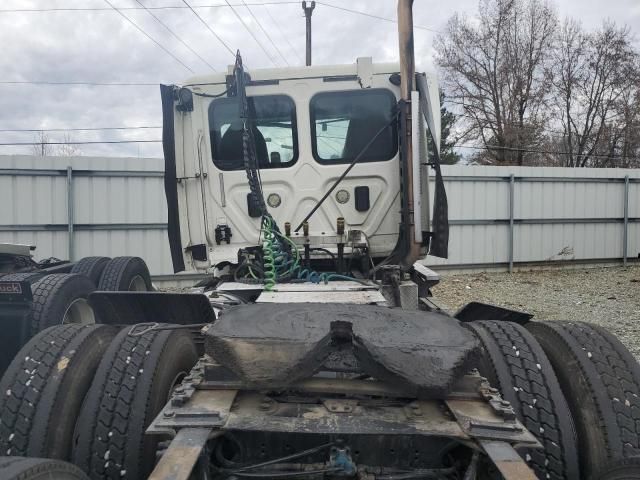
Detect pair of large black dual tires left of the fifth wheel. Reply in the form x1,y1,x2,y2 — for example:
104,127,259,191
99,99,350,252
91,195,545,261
0,324,198,480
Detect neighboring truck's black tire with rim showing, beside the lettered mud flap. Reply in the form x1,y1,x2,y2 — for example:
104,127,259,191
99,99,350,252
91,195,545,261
31,273,96,335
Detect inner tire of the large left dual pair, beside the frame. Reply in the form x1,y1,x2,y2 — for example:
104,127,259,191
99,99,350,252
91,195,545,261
73,324,198,480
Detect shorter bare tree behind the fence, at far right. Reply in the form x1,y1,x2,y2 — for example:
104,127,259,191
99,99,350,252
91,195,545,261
550,20,639,167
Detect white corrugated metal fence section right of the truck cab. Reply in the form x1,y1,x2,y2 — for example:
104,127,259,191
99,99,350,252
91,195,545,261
427,166,640,269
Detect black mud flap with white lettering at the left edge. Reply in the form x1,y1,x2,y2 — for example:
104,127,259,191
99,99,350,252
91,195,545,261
0,281,33,375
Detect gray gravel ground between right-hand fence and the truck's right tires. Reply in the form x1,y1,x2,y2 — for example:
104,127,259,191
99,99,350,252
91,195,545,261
433,265,640,360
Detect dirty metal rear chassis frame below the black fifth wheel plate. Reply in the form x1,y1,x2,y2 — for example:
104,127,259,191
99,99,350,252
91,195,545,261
147,359,540,480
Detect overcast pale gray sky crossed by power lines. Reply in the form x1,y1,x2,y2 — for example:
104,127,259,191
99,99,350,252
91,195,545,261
0,0,640,157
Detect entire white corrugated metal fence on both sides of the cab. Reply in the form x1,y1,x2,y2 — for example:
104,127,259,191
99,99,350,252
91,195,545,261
0,156,640,280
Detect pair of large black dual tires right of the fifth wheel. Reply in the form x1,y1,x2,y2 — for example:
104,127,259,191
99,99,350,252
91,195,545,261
469,321,640,480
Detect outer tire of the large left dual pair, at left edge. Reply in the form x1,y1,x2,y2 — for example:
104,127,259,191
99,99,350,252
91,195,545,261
0,325,116,462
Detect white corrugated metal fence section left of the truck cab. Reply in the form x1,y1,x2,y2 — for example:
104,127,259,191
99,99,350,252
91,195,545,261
0,156,172,275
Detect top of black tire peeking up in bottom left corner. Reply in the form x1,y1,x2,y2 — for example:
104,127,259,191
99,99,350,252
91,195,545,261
0,457,89,480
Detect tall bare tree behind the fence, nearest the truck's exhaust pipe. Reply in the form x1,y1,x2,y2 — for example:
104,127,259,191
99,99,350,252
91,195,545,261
436,0,557,165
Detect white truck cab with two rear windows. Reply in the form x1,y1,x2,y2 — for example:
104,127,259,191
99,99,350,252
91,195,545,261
164,58,440,271
